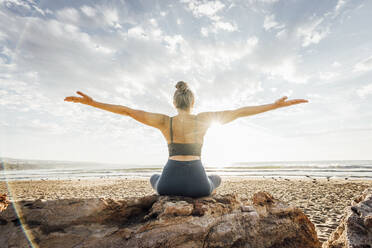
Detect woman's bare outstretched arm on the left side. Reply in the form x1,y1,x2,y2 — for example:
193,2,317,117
64,91,167,129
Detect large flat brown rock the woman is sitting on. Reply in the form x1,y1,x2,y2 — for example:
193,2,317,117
0,192,321,248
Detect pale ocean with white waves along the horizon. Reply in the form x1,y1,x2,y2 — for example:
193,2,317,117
0,158,372,181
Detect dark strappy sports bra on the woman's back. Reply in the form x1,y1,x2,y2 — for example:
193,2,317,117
168,117,203,156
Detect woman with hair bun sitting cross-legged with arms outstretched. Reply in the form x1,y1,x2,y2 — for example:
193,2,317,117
65,81,308,197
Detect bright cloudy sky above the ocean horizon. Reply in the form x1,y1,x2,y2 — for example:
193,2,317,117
0,0,372,165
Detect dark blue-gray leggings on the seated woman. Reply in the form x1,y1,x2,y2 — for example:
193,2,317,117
150,159,221,197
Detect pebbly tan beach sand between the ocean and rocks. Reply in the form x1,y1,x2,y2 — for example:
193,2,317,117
0,177,372,242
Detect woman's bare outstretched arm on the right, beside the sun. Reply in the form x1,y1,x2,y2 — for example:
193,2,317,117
199,96,308,124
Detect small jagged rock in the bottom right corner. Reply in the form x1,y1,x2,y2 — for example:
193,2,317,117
323,188,372,248
